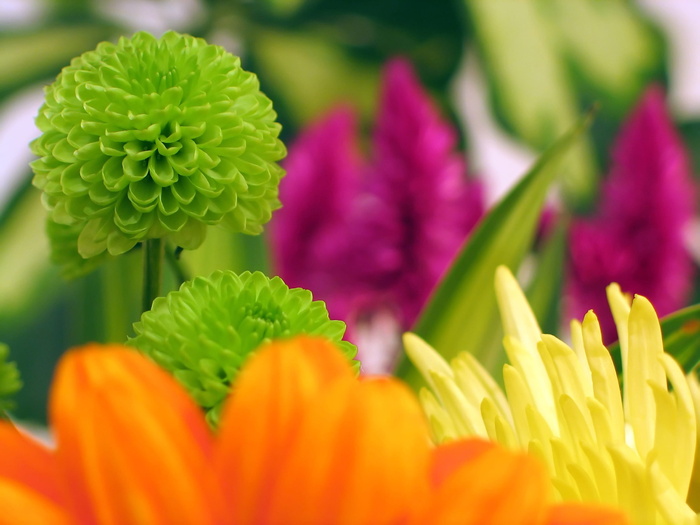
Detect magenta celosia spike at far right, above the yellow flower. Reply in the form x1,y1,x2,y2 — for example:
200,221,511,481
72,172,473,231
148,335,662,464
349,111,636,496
568,87,695,343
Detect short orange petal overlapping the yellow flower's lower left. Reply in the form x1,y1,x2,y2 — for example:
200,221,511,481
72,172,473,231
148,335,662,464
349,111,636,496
416,441,549,525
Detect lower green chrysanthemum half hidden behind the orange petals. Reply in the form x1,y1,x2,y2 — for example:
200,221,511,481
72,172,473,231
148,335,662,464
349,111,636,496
129,271,356,425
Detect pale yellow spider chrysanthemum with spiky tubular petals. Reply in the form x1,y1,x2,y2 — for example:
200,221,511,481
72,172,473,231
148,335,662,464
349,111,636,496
404,267,700,525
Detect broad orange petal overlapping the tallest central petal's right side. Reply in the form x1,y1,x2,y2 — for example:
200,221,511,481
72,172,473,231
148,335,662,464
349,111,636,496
264,378,430,525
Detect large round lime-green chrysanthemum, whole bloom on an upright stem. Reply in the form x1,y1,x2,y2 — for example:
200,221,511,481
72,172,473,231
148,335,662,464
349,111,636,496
32,32,285,258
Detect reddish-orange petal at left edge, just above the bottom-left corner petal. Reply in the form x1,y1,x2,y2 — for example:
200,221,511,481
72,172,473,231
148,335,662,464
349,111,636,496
0,422,62,502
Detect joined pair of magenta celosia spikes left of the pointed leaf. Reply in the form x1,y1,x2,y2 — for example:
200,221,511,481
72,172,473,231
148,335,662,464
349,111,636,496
271,60,483,368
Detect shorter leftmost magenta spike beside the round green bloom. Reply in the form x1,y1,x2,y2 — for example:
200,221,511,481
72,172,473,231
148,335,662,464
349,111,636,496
270,107,362,295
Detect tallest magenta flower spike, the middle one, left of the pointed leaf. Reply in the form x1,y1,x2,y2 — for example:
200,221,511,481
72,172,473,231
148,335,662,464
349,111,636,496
348,60,483,328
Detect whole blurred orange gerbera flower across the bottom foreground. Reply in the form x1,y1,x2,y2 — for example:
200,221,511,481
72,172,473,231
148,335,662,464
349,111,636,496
0,337,625,525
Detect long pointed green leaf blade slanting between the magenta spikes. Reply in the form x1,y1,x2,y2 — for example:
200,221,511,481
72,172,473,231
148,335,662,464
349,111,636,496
397,109,592,386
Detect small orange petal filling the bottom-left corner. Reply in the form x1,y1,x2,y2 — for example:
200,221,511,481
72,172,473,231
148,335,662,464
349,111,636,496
0,478,75,525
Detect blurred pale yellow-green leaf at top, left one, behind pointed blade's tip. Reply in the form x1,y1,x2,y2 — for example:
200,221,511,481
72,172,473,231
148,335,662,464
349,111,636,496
465,0,597,202
